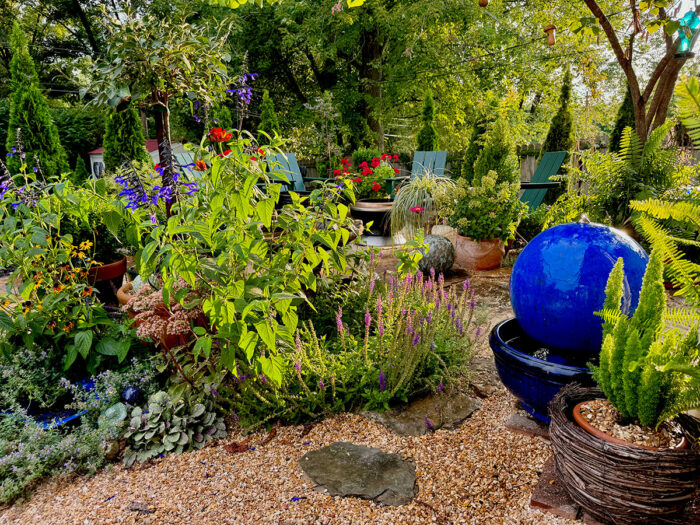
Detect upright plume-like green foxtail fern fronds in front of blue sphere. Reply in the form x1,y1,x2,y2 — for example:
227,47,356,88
592,250,700,426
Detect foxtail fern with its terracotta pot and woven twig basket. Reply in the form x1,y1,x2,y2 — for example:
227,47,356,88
550,250,700,523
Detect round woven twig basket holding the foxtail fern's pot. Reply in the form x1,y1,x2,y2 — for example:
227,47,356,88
549,385,700,525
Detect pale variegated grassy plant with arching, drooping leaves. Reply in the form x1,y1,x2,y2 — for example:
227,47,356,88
391,172,455,239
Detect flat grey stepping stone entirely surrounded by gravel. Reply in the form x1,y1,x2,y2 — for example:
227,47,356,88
299,441,418,505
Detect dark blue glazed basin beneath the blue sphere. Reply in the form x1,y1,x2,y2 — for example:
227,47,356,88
489,318,593,423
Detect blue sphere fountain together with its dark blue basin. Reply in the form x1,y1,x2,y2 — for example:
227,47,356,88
489,223,649,423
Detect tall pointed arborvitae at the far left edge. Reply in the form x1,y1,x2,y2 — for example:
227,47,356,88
6,22,69,177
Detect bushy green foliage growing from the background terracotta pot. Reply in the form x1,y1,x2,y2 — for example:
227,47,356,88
448,171,527,242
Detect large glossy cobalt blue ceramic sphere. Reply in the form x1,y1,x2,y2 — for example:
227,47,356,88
510,223,649,356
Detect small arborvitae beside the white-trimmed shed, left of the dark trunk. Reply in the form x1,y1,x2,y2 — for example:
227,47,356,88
102,105,151,171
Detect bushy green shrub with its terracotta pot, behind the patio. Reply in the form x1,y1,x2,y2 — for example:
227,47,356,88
440,171,527,270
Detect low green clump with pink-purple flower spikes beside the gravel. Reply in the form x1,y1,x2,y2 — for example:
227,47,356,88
231,268,482,425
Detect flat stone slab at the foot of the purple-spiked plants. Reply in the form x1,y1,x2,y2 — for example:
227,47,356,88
361,393,481,436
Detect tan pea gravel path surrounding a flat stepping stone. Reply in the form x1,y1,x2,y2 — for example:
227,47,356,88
0,391,577,525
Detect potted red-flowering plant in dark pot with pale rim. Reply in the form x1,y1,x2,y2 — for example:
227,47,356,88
342,153,398,236
